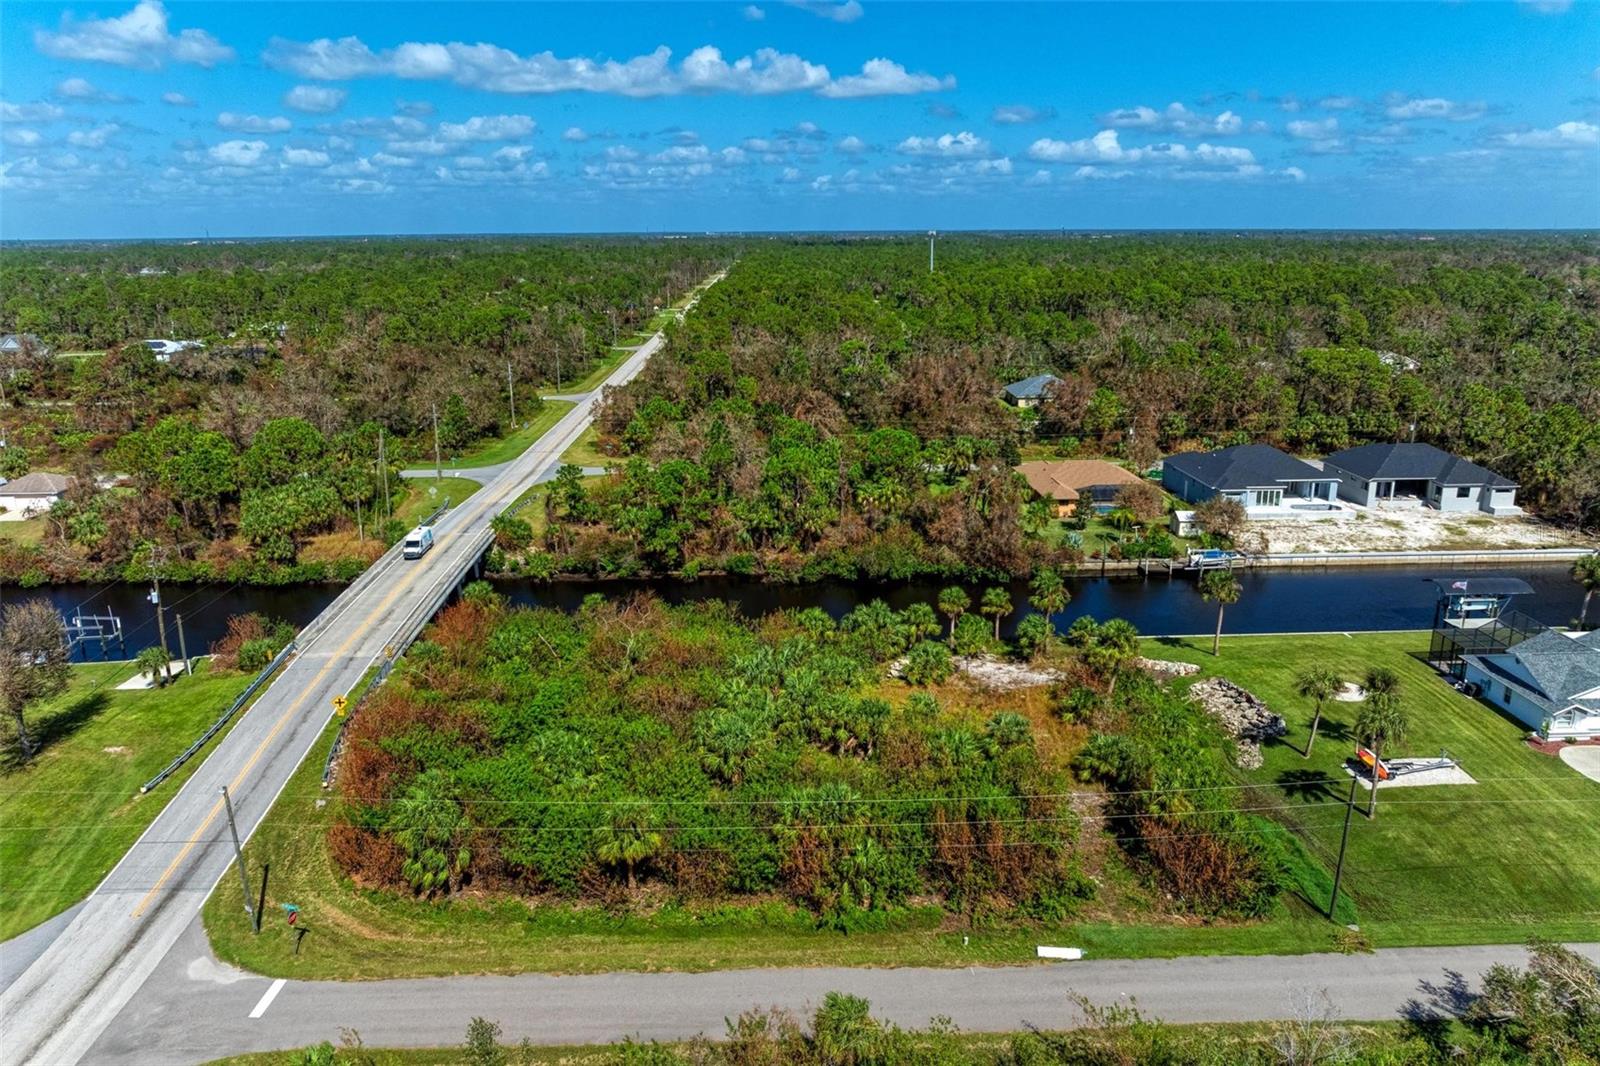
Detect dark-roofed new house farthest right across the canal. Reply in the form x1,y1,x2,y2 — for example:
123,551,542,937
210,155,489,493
1322,443,1522,515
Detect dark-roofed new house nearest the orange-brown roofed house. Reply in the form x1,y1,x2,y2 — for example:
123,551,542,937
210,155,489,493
1162,445,1339,519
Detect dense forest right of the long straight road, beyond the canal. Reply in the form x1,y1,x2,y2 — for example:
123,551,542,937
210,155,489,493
579,235,1600,582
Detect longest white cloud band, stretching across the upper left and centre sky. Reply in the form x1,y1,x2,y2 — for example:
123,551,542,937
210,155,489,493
262,37,955,98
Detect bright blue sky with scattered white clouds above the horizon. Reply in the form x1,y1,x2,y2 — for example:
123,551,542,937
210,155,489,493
0,0,1600,238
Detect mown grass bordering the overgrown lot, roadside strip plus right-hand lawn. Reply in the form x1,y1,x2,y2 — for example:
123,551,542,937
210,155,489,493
205,634,1600,980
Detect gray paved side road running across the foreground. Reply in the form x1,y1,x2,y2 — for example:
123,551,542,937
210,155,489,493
85,922,1600,1066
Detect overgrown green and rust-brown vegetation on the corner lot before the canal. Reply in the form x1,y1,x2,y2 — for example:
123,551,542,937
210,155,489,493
330,584,1288,928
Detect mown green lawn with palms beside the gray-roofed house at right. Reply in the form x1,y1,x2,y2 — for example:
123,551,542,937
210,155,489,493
1146,632,1600,944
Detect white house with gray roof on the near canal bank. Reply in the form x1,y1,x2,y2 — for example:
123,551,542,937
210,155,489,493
1464,629,1600,739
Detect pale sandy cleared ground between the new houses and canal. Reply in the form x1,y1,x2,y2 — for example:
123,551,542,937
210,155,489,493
1250,509,1600,552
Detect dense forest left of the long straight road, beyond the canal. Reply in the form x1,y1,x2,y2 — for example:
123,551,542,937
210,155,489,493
0,240,728,581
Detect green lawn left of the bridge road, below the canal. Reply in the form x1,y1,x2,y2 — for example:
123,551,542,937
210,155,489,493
0,661,260,940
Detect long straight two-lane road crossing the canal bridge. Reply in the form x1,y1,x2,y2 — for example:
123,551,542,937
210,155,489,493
0,273,726,1066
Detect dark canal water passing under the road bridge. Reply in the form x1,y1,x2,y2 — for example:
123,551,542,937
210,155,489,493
3,563,1582,658
